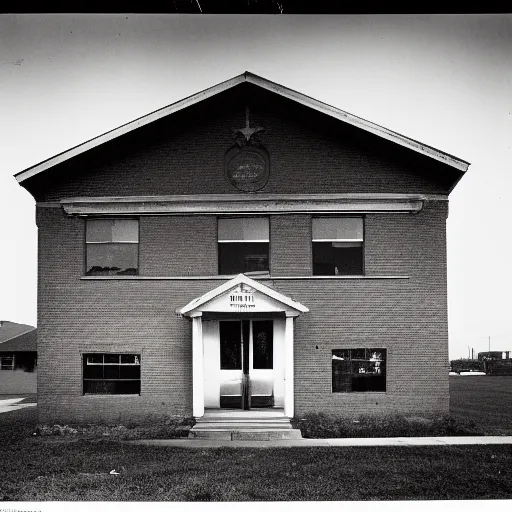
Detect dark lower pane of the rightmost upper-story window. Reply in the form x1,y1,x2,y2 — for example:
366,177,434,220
313,242,364,276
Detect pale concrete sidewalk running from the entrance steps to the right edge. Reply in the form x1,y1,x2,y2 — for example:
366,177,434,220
127,436,512,448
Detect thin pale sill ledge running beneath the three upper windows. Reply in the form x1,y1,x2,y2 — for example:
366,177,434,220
80,275,409,281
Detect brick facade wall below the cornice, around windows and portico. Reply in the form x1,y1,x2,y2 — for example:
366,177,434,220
37,202,448,422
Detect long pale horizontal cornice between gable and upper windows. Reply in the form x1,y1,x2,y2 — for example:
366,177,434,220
49,194,448,216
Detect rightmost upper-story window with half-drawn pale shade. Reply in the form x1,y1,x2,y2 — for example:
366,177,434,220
312,217,364,276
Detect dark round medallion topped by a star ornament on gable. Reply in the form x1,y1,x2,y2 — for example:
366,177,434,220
224,107,270,192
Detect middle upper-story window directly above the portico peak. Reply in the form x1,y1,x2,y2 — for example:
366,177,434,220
218,217,269,275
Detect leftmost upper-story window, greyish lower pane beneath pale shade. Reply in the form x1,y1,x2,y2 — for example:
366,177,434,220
85,219,139,276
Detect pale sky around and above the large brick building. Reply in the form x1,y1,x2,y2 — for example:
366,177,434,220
0,15,512,358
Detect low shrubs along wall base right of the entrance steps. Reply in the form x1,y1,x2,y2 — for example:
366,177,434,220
294,413,485,439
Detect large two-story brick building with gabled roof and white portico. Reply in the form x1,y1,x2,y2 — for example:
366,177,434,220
16,73,469,422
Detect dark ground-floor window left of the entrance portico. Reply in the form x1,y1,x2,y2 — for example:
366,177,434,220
83,354,140,395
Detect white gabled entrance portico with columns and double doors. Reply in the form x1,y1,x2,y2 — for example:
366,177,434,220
179,274,309,418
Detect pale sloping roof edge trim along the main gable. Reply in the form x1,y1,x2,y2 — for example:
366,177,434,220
15,71,469,183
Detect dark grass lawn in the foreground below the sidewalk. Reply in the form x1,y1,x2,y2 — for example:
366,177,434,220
0,408,512,501
